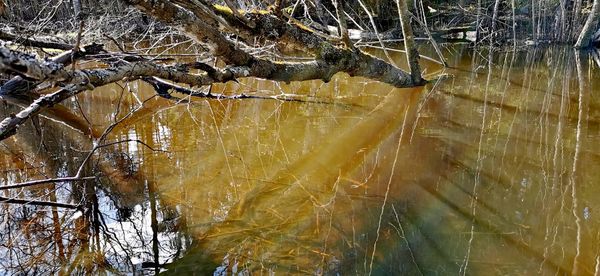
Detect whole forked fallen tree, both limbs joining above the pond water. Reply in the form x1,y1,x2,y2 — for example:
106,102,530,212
0,0,432,140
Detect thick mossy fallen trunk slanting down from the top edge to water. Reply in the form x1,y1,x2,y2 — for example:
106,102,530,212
125,0,422,87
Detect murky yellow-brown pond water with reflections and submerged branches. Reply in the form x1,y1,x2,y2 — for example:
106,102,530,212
0,46,600,275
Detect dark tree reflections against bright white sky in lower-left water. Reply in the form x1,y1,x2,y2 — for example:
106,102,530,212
0,88,195,275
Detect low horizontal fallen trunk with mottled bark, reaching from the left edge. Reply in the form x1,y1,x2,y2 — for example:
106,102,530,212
0,42,412,140
